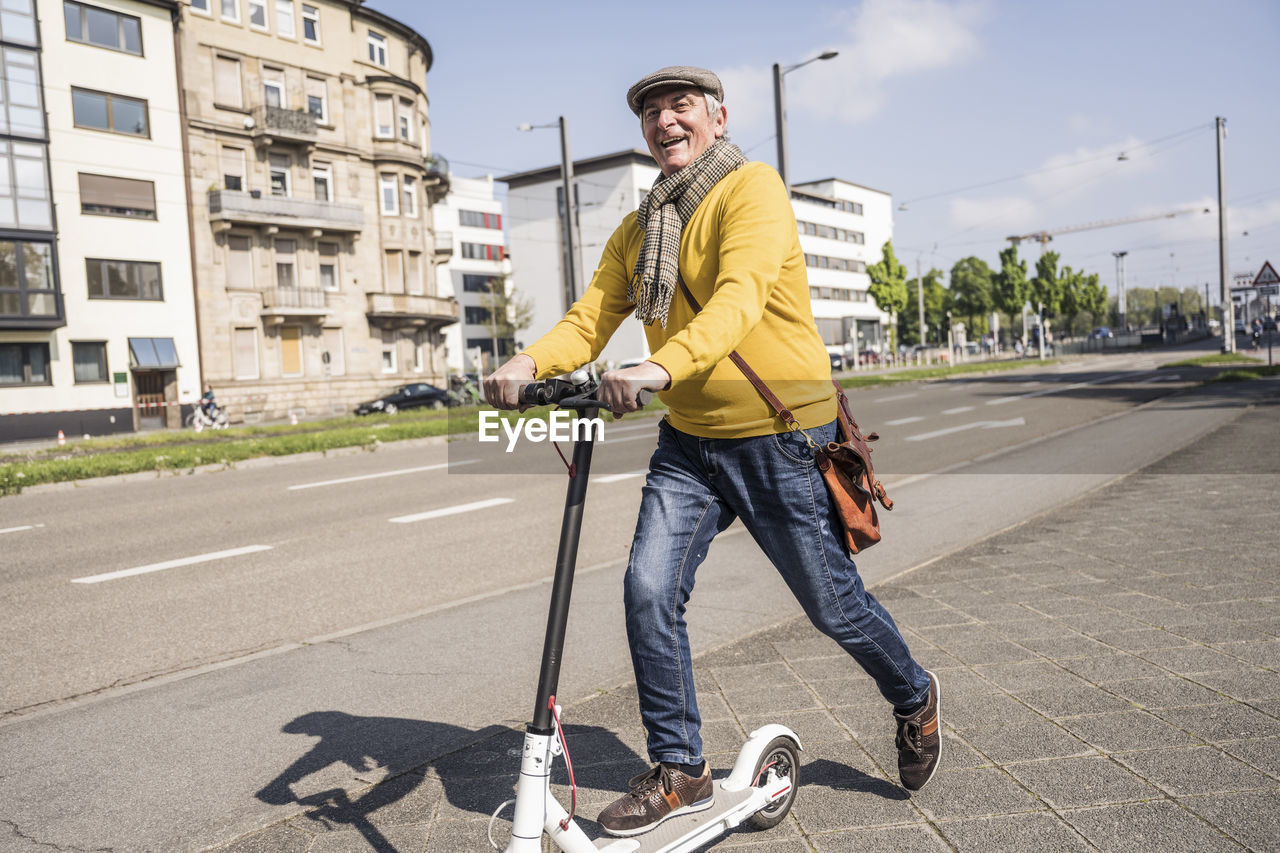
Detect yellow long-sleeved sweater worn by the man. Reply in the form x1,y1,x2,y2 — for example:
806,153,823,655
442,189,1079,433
525,163,836,438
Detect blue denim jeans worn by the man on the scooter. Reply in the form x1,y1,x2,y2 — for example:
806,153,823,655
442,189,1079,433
623,421,929,763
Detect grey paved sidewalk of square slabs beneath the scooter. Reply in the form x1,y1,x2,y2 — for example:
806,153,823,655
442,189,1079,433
220,383,1280,853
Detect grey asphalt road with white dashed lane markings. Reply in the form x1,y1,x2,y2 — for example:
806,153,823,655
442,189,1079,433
0,340,1239,850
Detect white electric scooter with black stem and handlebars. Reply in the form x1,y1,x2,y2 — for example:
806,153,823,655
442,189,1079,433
489,370,801,853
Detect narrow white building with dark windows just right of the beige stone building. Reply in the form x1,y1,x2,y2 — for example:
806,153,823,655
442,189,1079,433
434,175,509,373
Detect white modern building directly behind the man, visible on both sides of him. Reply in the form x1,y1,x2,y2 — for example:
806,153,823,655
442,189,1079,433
499,150,893,365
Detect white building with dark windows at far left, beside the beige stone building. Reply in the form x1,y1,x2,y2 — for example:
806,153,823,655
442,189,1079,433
0,0,201,439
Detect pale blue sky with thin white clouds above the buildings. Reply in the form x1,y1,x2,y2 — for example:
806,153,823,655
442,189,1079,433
367,0,1280,304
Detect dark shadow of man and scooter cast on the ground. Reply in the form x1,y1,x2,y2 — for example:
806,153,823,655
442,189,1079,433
256,711,646,853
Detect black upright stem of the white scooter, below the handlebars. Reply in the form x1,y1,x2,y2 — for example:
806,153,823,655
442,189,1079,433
527,417,596,735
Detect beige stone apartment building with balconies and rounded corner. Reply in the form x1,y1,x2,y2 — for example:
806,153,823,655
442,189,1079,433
178,0,458,420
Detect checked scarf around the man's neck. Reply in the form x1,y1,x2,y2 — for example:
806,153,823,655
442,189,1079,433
627,138,746,329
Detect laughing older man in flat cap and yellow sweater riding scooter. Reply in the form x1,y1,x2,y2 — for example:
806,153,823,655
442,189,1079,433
484,67,941,835
